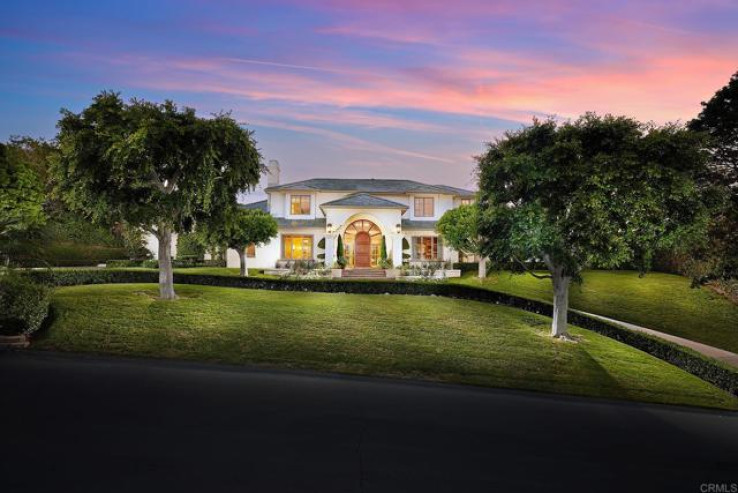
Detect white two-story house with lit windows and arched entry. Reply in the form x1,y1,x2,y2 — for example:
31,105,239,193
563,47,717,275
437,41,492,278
228,169,474,269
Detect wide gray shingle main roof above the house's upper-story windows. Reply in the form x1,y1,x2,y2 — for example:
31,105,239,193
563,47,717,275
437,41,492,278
266,178,474,197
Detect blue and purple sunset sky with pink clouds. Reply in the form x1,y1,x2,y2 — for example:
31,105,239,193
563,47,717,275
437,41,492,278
0,0,738,198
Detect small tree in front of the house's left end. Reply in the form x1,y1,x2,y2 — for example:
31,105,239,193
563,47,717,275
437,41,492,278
204,207,277,277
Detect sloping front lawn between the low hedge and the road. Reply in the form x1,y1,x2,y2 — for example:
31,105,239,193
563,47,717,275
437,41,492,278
33,284,738,409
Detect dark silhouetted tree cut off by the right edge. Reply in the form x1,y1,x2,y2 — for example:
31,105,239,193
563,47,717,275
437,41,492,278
689,72,738,277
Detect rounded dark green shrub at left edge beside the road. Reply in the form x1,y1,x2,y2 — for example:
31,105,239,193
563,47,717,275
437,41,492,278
0,272,49,335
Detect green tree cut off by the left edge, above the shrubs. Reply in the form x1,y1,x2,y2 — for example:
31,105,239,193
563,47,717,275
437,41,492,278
0,143,46,238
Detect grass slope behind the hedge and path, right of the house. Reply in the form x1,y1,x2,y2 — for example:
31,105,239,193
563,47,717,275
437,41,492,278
453,271,738,353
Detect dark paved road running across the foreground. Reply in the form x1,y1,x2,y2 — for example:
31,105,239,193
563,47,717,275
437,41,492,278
0,352,738,493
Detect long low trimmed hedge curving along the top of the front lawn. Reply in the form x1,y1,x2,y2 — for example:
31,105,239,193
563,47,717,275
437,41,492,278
29,269,738,396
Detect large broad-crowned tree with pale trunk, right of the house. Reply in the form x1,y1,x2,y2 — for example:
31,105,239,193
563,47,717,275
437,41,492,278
477,113,706,337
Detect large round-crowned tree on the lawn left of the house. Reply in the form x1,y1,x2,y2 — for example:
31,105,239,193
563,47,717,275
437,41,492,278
53,91,262,299
